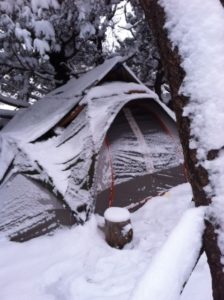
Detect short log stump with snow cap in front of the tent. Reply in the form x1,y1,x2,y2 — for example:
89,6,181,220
104,207,133,249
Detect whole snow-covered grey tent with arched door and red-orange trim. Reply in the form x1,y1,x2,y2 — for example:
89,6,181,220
0,57,184,241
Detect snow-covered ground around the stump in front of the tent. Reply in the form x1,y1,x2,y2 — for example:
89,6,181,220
0,184,212,300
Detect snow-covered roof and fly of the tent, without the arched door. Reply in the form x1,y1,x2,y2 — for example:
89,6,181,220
0,57,178,230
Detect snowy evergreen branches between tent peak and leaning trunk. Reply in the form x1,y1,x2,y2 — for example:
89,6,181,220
116,0,171,104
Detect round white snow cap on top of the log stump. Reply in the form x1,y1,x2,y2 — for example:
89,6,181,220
104,207,130,223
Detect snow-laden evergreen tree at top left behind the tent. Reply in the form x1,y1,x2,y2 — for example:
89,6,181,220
0,0,119,105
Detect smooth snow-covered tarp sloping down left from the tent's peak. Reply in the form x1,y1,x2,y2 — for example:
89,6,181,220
2,56,124,142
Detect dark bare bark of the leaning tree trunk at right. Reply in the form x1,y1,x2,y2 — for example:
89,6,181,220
140,0,224,300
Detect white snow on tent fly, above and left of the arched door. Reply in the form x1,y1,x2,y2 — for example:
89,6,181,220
16,82,155,207
